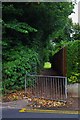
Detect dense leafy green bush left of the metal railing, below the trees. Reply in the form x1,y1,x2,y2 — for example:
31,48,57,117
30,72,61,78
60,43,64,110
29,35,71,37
3,45,40,91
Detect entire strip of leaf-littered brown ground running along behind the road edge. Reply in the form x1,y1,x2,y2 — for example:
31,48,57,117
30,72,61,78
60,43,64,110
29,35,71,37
2,91,80,110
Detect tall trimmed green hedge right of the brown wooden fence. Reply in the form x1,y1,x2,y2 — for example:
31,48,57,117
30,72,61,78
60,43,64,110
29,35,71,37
67,40,80,83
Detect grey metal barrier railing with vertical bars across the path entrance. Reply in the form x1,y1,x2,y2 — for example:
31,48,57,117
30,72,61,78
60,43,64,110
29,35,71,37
25,75,67,100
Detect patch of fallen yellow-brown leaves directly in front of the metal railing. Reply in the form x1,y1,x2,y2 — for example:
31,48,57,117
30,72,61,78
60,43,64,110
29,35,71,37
28,98,66,108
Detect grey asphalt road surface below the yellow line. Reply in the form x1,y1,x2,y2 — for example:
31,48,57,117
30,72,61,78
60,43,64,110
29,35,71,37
2,108,80,119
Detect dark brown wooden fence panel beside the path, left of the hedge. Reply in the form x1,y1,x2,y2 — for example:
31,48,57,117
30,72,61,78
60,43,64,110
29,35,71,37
51,47,67,76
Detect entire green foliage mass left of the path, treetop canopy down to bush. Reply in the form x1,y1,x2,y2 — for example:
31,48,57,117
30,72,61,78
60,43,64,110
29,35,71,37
2,2,74,91
